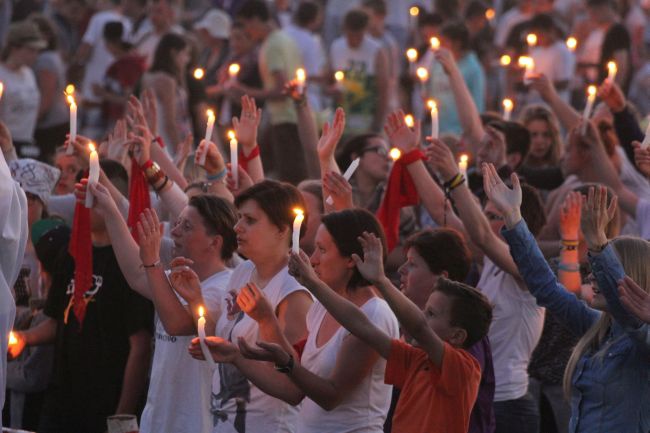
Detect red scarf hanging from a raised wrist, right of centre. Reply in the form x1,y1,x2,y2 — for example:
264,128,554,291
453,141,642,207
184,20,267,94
377,149,425,252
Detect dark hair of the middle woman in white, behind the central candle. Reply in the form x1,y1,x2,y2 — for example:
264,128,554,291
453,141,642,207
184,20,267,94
235,180,308,237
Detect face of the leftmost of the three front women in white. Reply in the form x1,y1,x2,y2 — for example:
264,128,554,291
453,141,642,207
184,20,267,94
171,206,214,261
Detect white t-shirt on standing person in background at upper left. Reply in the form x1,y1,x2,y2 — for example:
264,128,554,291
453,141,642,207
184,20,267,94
81,11,131,102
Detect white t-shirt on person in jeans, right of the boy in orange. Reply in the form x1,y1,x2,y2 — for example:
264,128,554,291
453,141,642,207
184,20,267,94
476,257,544,401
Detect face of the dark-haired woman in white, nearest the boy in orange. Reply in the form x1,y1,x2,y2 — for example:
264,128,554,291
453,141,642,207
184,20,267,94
310,224,355,288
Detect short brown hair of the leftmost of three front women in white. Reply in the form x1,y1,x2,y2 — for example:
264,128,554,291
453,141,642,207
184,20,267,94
188,194,237,260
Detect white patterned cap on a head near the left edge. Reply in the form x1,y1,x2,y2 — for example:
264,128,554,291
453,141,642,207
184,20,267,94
9,158,61,204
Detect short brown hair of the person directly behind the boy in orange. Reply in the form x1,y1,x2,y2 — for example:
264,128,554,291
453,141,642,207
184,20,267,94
404,227,472,281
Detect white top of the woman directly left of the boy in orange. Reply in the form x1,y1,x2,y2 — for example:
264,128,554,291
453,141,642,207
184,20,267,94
298,297,399,433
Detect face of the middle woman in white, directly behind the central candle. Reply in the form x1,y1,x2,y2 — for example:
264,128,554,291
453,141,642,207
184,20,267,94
235,200,289,261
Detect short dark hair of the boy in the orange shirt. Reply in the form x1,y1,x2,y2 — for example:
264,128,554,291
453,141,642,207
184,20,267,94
433,277,492,349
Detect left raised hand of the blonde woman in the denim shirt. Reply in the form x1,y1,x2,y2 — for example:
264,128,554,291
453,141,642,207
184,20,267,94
482,164,521,228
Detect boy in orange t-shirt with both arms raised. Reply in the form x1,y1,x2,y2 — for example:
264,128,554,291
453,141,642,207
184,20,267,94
289,233,492,433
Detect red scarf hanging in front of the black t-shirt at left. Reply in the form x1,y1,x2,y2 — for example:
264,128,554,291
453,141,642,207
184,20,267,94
68,201,93,328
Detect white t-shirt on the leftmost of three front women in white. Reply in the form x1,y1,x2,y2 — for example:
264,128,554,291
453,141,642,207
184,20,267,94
140,269,232,433
